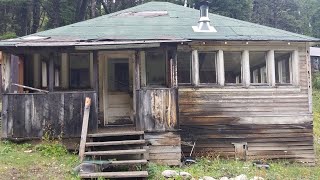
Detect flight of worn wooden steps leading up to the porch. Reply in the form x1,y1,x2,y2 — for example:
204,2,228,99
80,130,148,179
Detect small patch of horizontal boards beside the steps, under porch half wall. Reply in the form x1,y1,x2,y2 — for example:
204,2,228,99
145,132,181,165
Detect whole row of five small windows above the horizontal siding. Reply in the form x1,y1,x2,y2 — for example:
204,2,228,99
177,51,292,85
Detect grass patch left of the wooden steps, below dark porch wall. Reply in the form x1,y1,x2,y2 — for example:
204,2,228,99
0,141,79,179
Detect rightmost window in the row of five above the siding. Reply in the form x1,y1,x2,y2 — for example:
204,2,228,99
274,52,292,84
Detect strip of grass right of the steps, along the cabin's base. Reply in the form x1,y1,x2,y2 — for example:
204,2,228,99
148,158,320,180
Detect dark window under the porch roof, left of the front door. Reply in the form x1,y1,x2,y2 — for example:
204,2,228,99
69,53,90,89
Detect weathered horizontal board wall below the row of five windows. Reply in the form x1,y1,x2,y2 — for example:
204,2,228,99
178,44,315,163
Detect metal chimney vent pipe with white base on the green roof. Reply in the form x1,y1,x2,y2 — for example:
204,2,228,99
192,1,217,32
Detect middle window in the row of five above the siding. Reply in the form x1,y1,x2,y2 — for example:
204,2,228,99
224,51,242,84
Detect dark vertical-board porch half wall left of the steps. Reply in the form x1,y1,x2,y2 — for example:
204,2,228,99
2,92,98,138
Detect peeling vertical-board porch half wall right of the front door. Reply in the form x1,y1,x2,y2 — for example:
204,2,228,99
136,88,179,132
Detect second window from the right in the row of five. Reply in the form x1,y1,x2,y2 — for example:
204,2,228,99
250,52,267,84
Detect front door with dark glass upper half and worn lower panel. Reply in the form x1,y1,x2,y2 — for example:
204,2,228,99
104,58,133,125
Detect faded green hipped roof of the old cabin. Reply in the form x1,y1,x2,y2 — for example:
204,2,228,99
0,2,320,46
